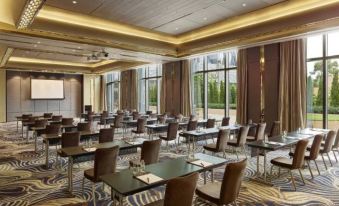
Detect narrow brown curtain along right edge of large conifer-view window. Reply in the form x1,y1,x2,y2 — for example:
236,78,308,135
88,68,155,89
237,49,248,124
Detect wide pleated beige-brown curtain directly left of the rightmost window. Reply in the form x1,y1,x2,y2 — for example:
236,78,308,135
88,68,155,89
278,39,306,131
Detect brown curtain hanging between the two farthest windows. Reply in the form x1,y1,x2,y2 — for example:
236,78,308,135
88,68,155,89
120,69,138,110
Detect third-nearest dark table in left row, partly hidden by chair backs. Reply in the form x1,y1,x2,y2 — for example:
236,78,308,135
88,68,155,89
42,131,99,168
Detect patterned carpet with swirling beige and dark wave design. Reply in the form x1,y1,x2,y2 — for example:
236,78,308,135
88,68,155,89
0,123,339,206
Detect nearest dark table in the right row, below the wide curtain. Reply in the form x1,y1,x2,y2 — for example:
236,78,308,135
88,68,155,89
246,128,330,185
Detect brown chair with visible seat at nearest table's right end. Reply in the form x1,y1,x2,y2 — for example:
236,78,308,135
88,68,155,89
195,159,247,205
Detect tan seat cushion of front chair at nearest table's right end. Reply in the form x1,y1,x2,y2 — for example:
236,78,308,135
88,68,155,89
195,182,221,204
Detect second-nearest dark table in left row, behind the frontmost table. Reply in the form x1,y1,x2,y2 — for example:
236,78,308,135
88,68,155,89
59,140,143,194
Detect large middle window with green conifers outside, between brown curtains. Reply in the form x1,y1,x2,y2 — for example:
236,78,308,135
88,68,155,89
190,50,237,121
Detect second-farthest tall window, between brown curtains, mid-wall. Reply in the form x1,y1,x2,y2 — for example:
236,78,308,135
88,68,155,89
138,64,162,113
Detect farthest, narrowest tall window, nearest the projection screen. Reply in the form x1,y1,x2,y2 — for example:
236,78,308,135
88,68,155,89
106,72,120,112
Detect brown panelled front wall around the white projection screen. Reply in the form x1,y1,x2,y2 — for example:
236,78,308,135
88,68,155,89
6,71,83,121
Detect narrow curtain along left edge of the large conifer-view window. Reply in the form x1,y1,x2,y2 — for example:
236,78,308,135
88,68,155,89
180,60,192,116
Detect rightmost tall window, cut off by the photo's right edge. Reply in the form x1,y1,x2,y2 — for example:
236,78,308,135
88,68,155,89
306,31,339,129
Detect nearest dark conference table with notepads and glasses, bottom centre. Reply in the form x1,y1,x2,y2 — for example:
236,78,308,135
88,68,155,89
100,153,227,205
